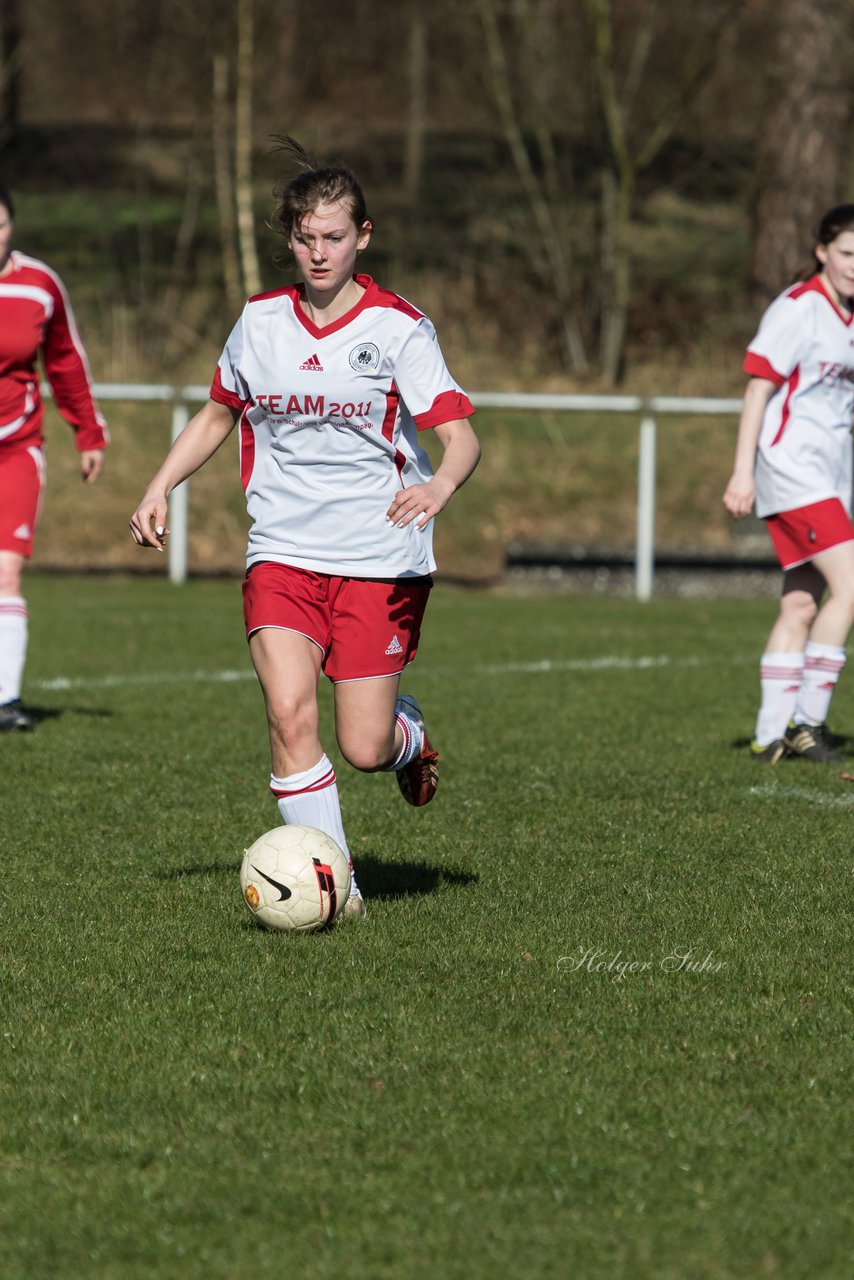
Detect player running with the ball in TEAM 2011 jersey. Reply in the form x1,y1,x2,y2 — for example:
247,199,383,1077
131,138,480,915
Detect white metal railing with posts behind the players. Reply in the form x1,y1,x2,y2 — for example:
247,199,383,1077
56,383,741,600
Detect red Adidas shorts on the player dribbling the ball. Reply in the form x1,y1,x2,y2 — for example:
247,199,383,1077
243,561,433,681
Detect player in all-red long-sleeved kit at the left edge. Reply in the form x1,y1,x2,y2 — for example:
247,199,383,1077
0,186,108,731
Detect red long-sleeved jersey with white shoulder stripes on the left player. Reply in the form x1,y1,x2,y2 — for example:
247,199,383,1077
0,251,109,452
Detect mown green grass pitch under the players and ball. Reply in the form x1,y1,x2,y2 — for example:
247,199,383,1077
0,573,854,1280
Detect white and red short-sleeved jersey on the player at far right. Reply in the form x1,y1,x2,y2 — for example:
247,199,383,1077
744,275,854,516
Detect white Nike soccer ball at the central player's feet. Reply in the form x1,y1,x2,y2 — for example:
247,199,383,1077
241,826,350,933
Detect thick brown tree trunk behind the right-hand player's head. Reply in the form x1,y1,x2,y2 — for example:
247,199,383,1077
753,0,854,307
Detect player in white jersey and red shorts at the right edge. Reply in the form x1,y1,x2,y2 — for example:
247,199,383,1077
723,205,854,764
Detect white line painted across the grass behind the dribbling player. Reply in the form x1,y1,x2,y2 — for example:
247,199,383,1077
31,654,727,691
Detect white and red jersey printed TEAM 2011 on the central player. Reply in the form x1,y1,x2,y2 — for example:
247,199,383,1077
210,275,474,577
